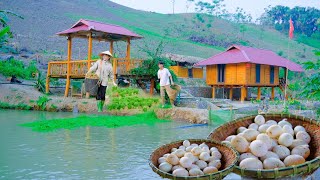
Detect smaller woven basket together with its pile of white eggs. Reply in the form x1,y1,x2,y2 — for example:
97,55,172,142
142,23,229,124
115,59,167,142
149,139,239,179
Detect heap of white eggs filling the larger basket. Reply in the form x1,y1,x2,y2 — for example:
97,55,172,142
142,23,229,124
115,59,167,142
223,115,311,169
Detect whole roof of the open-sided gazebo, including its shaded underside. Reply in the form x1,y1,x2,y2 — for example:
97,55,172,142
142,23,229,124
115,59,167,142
57,19,143,41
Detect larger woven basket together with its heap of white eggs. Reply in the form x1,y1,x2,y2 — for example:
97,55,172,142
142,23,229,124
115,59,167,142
208,114,320,178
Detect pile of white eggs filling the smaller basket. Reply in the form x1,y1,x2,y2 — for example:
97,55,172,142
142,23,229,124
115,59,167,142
158,140,222,176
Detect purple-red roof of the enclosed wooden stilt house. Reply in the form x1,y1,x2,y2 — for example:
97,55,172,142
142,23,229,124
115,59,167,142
196,45,303,72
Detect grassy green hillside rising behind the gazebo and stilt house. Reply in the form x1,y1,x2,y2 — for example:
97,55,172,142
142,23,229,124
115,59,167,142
0,0,314,61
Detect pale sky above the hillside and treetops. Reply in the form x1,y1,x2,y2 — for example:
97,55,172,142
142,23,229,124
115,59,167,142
111,0,320,19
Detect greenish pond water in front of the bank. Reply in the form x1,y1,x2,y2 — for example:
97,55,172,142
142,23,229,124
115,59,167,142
0,110,238,179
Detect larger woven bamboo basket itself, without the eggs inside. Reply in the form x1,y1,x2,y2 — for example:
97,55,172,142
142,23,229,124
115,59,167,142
208,114,320,178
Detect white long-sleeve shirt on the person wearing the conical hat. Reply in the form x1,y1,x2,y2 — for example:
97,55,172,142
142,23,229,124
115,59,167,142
88,59,114,86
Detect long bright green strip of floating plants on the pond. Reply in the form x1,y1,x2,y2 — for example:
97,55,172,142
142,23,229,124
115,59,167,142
20,112,168,132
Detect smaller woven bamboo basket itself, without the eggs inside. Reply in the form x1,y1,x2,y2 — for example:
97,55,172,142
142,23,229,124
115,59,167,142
149,139,239,180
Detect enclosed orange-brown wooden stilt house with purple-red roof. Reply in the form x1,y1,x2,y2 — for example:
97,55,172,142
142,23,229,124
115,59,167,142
197,45,303,101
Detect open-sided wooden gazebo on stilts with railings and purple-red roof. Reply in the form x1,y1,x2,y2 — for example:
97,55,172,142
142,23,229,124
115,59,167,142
46,19,142,97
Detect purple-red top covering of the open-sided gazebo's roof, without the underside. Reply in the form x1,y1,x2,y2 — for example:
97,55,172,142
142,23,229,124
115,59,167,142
57,19,142,38
